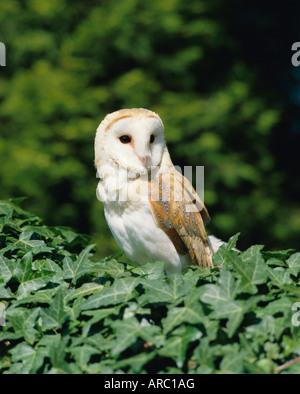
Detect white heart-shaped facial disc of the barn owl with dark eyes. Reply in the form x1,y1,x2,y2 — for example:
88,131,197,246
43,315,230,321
103,116,165,173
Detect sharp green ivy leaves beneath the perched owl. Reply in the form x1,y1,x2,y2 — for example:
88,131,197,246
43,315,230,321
0,200,300,374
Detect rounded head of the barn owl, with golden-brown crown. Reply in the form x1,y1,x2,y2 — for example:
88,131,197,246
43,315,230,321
95,108,166,173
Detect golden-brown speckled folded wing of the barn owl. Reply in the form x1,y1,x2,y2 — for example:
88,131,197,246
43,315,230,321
149,170,212,267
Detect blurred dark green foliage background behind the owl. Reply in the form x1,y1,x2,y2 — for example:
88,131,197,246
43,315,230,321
0,0,300,256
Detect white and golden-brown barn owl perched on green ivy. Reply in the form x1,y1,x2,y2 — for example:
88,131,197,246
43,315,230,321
95,108,221,275
